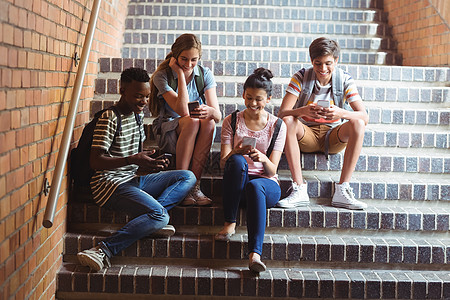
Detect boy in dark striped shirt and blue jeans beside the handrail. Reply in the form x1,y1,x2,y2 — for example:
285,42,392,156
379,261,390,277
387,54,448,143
77,68,195,271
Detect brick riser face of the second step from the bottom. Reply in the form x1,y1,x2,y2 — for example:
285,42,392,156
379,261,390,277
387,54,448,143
64,234,450,268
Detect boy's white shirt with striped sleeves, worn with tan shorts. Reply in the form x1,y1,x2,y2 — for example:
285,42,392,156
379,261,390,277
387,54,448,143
286,70,362,126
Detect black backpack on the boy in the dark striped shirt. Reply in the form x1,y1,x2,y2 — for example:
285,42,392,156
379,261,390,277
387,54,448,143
70,106,122,188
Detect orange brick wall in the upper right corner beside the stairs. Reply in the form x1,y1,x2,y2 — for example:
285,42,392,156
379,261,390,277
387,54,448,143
384,0,450,66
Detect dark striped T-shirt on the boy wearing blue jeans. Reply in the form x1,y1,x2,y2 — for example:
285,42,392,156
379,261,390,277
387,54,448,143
91,110,145,206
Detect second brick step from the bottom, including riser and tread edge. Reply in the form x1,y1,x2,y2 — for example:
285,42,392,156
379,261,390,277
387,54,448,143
64,230,450,271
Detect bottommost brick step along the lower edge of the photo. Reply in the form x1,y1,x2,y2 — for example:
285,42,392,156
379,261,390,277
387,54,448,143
56,263,450,299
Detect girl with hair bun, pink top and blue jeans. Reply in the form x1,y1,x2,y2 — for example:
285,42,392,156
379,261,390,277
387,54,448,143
215,68,286,272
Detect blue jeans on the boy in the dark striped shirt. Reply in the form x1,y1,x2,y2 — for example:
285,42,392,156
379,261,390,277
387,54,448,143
100,170,196,257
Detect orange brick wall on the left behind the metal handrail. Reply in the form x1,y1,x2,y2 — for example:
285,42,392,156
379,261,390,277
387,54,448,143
0,0,128,299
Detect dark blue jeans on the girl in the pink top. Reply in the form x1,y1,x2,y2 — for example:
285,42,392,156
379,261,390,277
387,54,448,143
223,154,281,255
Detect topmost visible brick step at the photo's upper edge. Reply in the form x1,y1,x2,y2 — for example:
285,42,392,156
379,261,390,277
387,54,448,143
128,1,387,23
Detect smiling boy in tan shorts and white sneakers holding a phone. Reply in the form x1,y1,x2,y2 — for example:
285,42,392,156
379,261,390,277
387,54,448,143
278,38,368,209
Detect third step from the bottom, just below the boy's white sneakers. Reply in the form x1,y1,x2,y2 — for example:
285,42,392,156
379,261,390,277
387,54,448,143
68,202,450,232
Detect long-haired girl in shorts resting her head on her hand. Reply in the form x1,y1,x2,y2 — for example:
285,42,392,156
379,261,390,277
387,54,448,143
150,34,222,206
